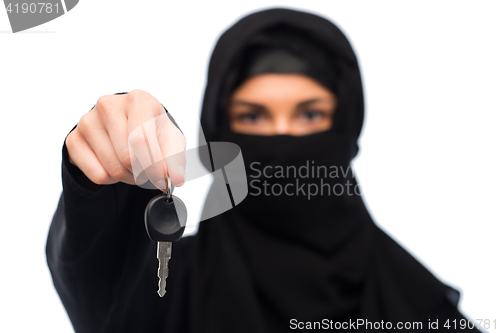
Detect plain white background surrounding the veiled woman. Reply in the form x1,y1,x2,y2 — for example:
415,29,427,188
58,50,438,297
0,0,500,333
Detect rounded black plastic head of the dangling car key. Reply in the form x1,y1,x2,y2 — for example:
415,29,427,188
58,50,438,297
144,194,187,242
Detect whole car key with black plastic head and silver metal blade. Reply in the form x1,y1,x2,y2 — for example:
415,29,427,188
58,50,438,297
144,176,187,297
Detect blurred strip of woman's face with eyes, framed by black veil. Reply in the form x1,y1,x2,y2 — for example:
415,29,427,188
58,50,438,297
228,74,337,135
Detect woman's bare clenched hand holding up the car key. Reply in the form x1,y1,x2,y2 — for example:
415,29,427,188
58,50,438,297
66,90,186,190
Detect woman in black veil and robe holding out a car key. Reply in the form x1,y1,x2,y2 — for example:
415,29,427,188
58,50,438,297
47,9,476,332
